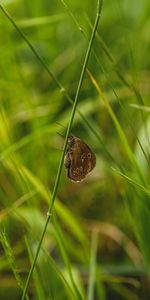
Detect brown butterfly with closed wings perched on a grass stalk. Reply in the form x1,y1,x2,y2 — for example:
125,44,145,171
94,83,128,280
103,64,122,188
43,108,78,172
64,134,96,182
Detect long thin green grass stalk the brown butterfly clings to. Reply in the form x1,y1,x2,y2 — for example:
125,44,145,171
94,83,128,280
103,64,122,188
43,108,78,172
21,0,103,300
